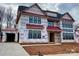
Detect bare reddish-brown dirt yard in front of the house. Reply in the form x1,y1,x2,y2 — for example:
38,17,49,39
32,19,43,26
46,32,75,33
21,43,79,55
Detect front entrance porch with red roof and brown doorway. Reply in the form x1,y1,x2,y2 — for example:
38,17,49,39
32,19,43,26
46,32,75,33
47,26,62,43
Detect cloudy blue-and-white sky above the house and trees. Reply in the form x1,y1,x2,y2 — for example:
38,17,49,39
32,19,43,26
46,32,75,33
0,3,79,23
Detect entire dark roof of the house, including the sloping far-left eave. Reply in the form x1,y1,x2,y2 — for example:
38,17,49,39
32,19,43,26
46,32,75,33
16,3,74,23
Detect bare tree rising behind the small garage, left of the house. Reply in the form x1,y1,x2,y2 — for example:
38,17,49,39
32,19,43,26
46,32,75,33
6,7,13,28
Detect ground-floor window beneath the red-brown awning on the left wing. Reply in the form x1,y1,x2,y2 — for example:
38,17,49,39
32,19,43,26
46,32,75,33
28,30,41,39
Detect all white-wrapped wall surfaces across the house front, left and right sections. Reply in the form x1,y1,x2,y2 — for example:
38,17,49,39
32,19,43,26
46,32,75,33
18,15,75,43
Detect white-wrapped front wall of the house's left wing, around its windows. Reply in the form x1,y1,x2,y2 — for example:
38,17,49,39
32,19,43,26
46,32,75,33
18,15,48,43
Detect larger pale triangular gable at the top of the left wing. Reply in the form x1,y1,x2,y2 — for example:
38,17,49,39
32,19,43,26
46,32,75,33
24,5,44,15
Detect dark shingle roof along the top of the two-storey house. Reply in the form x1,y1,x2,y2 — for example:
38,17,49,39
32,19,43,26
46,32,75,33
18,3,74,21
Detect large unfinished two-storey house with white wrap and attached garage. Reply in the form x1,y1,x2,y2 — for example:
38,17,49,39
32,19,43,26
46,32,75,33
0,4,75,43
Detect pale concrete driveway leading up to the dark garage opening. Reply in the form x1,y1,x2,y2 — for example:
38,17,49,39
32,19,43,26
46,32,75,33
0,43,29,56
